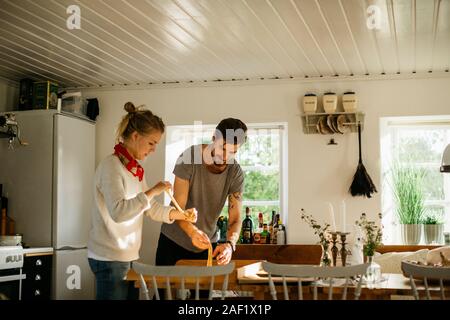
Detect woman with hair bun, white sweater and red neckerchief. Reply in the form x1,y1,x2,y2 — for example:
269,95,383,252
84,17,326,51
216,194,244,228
88,102,197,300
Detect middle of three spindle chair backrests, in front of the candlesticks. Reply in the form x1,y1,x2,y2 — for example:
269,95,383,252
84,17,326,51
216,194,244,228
262,261,369,300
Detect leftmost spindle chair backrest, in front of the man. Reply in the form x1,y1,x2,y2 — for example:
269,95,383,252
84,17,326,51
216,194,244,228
132,262,234,300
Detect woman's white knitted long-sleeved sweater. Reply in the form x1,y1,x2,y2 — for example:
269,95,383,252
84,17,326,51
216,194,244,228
88,155,173,262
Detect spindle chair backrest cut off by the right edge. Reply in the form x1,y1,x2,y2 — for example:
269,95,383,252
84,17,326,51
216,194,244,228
402,261,450,300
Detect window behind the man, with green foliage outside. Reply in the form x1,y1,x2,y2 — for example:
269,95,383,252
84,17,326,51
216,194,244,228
166,123,287,223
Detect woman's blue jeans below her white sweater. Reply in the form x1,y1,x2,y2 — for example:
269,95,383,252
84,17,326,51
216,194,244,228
88,258,131,300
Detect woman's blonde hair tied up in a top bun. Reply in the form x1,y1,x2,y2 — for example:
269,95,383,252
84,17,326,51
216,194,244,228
116,102,165,143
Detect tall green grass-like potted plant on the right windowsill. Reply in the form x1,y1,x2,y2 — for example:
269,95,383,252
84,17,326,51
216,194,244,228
392,164,426,245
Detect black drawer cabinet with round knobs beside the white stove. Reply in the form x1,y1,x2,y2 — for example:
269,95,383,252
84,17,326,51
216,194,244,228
22,252,53,300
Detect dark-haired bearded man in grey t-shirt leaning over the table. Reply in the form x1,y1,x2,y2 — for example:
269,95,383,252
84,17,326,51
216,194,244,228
156,118,247,265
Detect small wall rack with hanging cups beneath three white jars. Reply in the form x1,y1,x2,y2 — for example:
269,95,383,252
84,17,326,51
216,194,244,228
301,112,364,135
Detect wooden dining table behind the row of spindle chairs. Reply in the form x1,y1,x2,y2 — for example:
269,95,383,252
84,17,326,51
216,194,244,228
127,260,450,300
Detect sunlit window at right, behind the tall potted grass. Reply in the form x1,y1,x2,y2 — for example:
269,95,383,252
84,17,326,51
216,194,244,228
381,116,450,243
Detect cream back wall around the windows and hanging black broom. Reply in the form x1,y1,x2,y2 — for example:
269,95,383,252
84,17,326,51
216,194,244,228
84,78,450,262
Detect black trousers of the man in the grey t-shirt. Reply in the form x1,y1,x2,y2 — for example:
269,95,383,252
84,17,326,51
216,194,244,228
155,233,217,266
